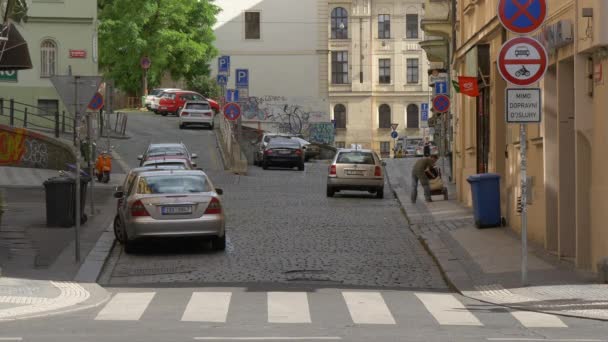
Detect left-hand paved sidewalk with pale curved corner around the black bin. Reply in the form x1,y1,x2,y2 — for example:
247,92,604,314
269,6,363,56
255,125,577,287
0,167,118,321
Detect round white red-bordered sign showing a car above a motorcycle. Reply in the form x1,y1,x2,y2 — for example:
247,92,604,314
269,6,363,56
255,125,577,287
498,37,548,86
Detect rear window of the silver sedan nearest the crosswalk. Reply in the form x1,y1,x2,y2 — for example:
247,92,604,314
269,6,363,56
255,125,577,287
137,175,212,195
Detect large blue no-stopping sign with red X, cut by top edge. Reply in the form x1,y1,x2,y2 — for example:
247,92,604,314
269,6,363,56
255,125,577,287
498,0,547,34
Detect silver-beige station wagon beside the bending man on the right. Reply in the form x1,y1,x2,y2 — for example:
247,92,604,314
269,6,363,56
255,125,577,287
327,149,384,198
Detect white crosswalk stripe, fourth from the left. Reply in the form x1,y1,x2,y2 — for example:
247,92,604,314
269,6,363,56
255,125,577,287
342,292,396,324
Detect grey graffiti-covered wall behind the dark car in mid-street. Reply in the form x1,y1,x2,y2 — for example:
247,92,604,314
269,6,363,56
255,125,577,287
241,96,334,145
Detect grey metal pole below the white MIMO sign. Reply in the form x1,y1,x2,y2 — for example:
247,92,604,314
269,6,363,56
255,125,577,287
519,123,528,286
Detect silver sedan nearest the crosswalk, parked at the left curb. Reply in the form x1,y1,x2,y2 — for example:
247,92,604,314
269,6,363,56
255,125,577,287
114,170,226,253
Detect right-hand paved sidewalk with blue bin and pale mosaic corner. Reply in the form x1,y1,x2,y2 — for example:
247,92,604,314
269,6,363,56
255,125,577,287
386,159,608,320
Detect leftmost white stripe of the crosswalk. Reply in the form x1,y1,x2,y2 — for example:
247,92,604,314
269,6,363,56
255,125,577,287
95,292,156,321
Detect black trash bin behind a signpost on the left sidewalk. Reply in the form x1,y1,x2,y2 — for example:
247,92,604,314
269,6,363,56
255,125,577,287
44,176,91,227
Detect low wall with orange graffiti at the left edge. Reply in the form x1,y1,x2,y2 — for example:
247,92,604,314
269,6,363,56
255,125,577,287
0,125,75,170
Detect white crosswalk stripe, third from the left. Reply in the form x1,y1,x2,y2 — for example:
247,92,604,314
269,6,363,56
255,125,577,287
268,292,311,323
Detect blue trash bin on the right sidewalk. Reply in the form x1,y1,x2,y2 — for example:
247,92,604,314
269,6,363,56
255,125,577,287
467,173,501,228
